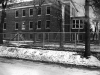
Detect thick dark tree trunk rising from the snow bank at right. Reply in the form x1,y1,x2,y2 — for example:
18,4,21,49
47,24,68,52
84,0,91,58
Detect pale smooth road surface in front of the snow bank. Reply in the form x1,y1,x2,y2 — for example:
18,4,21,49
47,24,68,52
0,58,100,75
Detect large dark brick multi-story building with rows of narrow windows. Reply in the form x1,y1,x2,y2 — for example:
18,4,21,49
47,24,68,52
0,0,78,39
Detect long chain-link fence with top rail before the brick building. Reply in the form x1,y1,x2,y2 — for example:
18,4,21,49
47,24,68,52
2,32,100,50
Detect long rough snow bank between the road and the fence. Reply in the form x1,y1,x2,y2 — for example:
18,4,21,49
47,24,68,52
0,46,100,67
